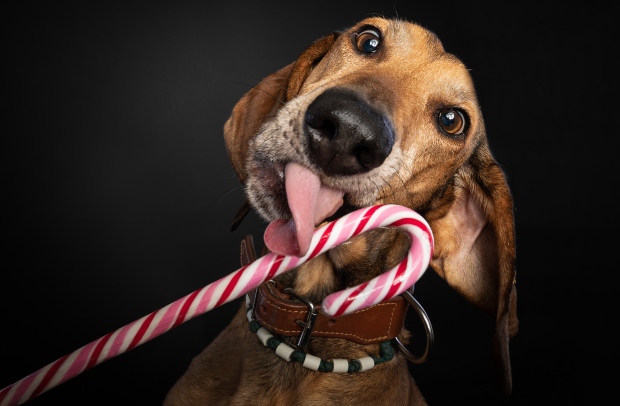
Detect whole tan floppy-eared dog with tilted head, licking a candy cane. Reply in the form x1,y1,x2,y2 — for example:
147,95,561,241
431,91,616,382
164,17,518,406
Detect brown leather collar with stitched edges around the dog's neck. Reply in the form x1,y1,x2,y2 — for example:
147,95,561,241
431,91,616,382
250,282,408,344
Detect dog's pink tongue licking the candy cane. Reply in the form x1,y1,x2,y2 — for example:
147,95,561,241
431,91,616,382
264,162,344,257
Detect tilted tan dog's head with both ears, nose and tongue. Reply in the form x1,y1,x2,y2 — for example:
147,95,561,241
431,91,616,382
224,18,518,393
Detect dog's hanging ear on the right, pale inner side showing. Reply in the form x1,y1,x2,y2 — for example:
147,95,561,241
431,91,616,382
427,139,518,394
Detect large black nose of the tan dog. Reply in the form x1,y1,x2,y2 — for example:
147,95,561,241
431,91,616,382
305,88,394,175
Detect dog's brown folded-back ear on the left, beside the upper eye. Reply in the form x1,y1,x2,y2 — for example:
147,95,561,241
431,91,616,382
224,33,338,183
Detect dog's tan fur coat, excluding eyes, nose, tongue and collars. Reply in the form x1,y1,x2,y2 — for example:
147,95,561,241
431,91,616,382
165,18,518,406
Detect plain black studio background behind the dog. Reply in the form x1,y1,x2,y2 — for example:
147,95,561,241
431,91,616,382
0,1,619,405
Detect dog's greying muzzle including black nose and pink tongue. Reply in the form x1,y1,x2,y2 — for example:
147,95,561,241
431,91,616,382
251,88,398,257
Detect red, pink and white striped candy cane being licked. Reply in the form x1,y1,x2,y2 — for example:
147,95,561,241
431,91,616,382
0,205,434,406
